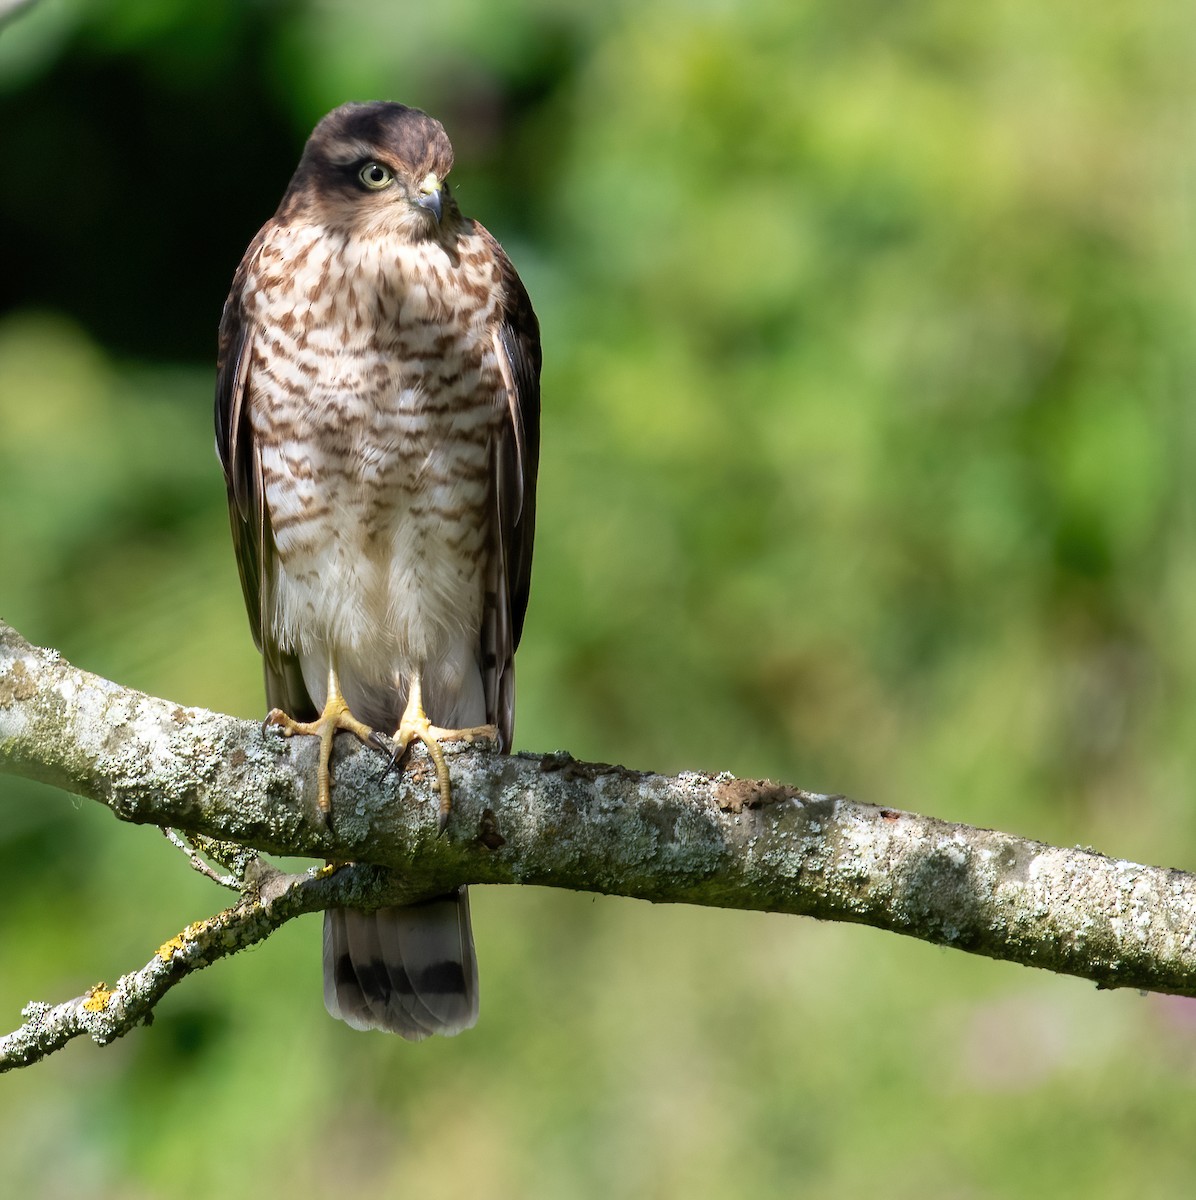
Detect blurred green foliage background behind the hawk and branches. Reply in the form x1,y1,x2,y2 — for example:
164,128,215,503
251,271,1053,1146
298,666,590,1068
0,0,1196,1200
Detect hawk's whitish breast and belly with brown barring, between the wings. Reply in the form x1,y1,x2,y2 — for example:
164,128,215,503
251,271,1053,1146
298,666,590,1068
242,216,505,659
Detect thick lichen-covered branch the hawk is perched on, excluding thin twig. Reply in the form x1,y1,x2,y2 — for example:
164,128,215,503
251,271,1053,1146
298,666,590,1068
0,623,1196,1070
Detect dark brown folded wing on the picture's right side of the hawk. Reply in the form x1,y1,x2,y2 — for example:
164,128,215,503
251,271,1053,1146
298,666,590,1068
474,222,541,750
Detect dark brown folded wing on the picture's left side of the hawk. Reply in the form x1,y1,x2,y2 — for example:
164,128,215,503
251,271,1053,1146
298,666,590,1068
216,224,315,720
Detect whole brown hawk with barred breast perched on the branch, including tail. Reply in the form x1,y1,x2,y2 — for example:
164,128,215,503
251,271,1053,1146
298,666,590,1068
216,102,540,1039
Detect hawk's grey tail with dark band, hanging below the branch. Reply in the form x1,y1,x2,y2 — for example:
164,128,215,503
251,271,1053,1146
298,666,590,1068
324,888,477,1042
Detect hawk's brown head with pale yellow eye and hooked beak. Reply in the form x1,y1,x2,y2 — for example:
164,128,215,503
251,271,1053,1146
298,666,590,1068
280,101,459,241
